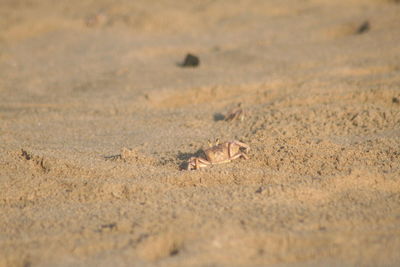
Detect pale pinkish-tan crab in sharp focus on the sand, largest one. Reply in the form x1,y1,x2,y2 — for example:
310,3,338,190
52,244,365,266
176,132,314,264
187,139,250,171
